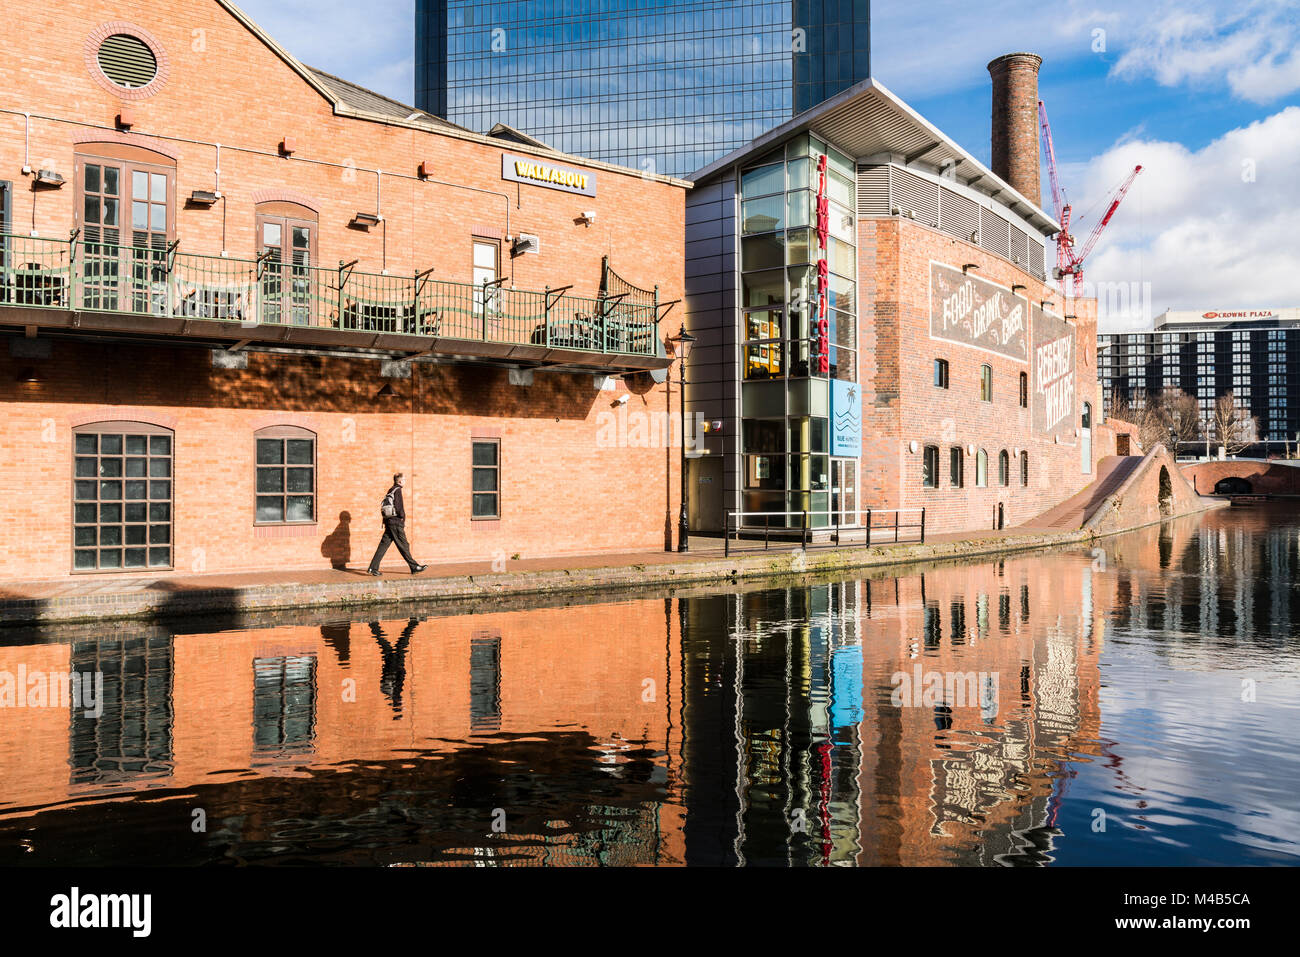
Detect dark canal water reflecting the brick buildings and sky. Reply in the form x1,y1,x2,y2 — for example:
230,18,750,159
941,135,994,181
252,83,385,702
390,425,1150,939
0,507,1300,866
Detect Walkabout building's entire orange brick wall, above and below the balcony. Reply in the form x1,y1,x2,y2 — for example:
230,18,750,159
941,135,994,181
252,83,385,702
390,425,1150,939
0,0,685,577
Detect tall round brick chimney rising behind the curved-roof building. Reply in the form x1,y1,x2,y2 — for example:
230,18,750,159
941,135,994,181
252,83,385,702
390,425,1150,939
988,53,1043,205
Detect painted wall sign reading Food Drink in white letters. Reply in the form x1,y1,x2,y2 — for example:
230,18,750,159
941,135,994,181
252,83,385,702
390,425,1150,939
930,263,1030,363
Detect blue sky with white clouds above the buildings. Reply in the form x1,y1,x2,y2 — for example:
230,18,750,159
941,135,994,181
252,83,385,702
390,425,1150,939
233,0,1300,329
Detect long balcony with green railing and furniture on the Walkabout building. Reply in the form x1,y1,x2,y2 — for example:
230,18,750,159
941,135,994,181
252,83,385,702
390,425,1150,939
0,234,668,373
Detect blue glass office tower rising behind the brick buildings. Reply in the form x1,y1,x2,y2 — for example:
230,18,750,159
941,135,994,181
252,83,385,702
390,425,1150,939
416,0,870,176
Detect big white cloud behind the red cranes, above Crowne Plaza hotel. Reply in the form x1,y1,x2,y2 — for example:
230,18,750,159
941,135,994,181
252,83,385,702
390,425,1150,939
1065,107,1300,321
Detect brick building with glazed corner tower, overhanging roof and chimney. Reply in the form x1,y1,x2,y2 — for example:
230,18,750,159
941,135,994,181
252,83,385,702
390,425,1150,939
686,53,1114,531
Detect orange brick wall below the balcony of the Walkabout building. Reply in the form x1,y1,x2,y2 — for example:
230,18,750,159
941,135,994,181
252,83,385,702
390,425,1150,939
0,343,679,579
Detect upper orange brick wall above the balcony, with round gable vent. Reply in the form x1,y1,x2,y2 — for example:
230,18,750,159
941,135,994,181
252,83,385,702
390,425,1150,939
0,0,685,299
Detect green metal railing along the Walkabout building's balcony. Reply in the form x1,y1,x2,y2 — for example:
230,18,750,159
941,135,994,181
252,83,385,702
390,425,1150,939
0,233,658,356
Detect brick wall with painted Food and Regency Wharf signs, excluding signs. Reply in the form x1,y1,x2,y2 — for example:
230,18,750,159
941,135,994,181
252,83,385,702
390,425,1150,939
858,217,1114,532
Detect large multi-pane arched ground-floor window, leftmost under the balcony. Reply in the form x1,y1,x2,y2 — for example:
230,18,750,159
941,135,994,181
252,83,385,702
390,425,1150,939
73,421,173,572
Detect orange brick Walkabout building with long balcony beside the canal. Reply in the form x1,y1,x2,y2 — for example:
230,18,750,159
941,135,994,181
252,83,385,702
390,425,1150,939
0,0,686,577
